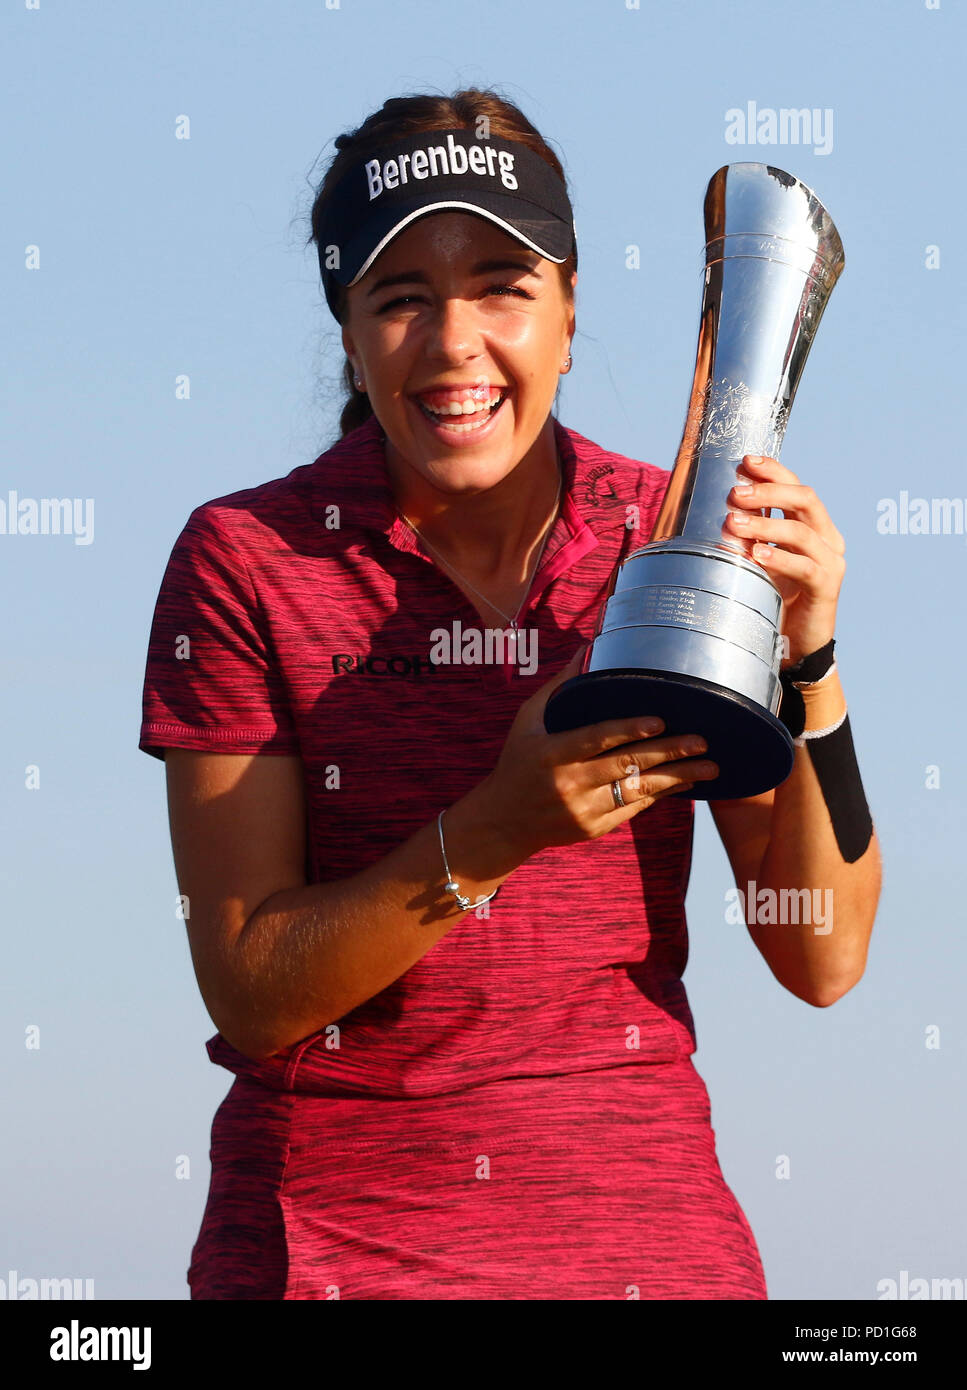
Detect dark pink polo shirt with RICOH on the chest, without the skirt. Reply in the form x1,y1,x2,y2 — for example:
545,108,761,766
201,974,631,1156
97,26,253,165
140,420,695,1095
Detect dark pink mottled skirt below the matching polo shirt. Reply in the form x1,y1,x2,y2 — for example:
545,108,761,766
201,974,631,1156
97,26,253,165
188,1058,768,1300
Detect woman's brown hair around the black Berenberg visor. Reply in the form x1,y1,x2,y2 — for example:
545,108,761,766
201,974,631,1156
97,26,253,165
306,88,578,438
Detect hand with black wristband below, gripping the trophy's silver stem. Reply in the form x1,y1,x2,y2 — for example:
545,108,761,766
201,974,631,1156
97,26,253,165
722,453,846,667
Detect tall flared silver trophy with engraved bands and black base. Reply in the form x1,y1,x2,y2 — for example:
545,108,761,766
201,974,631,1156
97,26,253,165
545,164,845,801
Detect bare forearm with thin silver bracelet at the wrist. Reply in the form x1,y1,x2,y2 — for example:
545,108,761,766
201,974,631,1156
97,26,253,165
220,781,517,1058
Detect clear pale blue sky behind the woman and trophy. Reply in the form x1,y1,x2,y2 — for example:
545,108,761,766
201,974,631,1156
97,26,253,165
0,0,967,1300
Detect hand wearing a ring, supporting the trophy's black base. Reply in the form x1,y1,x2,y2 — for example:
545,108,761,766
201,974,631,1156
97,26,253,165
478,648,718,862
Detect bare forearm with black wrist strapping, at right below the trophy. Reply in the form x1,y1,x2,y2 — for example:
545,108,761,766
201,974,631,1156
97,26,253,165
746,673,881,1005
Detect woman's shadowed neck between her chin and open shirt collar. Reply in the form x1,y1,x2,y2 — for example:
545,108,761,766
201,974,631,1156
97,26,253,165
386,417,563,581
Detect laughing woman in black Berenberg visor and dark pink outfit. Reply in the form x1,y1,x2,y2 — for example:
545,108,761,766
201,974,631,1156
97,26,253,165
140,90,879,1300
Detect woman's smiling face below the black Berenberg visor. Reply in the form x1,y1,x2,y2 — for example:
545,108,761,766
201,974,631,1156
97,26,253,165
342,213,577,493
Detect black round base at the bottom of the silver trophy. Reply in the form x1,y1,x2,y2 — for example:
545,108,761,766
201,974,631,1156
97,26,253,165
545,667,796,801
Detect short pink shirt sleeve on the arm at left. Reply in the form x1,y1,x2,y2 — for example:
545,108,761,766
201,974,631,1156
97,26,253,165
138,507,299,759
